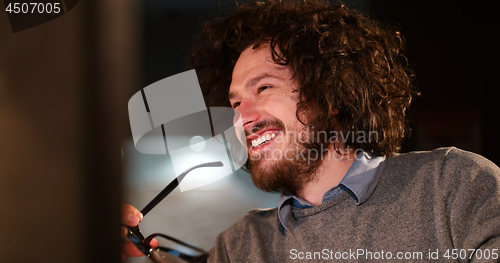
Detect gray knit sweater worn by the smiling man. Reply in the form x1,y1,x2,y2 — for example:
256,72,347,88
208,148,500,262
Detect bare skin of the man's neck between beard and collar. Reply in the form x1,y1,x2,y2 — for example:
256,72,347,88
297,150,356,206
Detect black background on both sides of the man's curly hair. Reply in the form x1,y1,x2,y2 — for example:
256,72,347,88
143,0,500,164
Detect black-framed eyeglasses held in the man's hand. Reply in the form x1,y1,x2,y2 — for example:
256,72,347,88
125,162,223,263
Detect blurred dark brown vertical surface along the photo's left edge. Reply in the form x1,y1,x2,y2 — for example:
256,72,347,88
0,0,139,263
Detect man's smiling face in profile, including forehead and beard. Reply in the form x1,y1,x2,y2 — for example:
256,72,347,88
229,45,318,193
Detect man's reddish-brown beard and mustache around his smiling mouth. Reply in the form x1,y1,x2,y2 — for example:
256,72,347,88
246,120,327,195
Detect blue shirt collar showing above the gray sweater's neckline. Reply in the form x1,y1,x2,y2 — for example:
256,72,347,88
278,152,385,229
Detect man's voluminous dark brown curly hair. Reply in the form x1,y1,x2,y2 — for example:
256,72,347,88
190,0,418,156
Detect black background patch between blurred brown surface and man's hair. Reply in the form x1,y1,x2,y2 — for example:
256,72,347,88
143,0,224,85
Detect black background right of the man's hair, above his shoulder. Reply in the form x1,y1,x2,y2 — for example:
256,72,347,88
370,0,500,164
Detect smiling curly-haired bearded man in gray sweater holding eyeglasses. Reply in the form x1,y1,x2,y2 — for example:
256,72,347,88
124,1,500,262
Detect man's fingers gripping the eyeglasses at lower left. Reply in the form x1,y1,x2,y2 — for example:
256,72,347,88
122,204,158,261
